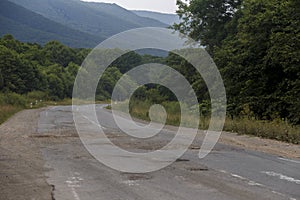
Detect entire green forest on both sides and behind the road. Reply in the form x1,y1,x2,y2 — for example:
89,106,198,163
0,0,300,143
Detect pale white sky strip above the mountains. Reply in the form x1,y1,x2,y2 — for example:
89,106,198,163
83,0,177,14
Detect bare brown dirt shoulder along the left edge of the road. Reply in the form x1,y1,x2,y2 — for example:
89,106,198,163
0,109,52,200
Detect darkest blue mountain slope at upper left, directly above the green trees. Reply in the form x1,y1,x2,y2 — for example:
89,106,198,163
0,0,105,47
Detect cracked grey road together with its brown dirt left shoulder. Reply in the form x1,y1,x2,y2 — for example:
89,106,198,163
0,105,300,200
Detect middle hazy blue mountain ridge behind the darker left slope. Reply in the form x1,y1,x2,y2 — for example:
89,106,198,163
10,0,168,37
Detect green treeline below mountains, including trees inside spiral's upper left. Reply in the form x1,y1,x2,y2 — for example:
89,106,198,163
0,35,164,102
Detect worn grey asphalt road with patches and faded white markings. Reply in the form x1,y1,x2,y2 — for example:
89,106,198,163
35,105,300,200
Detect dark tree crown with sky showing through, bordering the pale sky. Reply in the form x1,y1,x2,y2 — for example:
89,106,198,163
173,0,242,55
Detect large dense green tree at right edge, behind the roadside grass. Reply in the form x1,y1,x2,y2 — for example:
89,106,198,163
215,0,300,123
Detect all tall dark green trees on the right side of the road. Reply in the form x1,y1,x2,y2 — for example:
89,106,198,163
171,0,300,124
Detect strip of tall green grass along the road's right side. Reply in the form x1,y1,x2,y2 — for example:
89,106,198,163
117,101,300,144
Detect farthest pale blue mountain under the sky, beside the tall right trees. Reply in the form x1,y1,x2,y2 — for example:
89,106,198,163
132,10,179,25
